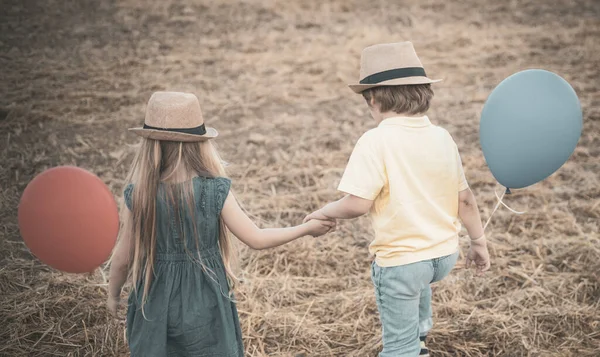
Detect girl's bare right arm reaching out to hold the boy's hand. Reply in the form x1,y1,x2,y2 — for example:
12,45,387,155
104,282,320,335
221,192,335,250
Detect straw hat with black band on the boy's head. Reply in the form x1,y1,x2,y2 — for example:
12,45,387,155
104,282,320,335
349,41,441,93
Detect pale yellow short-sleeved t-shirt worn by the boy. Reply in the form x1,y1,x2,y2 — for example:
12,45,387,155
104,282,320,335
338,116,469,267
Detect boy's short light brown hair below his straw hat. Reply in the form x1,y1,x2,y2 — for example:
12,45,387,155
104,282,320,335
362,84,433,115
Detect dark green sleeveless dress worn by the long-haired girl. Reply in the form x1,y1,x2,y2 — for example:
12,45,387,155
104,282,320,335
124,177,244,357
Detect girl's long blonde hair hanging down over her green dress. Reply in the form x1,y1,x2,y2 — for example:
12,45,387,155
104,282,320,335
121,138,237,307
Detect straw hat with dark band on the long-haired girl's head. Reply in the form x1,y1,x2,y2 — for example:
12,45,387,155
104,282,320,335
129,92,219,141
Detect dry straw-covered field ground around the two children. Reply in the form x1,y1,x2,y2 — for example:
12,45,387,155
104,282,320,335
0,0,600,357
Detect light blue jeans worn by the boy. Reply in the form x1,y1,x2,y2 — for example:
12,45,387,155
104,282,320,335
371,252,458,357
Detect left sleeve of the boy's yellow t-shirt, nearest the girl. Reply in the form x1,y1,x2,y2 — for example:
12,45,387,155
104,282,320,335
338,135,386,200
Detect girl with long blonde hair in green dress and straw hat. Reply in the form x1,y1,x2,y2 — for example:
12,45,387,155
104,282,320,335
107,92,335,357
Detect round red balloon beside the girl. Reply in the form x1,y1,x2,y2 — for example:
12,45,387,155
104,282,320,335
18,166,119,273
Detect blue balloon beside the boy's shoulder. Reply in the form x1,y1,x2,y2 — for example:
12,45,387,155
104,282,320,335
479,69,583,188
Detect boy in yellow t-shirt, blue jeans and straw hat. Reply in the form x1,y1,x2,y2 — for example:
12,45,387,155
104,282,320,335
306,42,490,357
